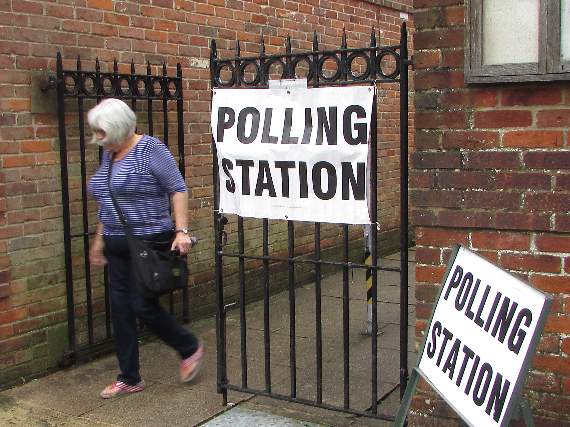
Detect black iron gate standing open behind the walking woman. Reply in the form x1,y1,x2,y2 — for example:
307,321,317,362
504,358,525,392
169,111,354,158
56,53,188,365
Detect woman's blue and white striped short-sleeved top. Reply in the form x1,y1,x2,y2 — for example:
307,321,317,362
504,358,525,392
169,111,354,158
87,135,186,235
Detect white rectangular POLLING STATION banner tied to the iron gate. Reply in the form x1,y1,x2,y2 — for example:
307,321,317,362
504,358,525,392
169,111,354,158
211,86,374,224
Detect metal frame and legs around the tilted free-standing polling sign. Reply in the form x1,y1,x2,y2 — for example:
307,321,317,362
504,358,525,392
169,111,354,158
394,245,552,427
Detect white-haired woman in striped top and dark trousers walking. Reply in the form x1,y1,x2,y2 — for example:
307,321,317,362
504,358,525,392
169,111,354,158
87,98,203,399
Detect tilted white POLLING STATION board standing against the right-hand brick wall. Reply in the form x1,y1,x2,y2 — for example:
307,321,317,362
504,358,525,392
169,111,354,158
418,248,549,427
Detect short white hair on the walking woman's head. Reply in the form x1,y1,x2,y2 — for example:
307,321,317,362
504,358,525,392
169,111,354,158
87,98,137,146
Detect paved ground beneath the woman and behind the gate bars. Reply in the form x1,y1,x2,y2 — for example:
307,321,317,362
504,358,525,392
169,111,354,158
0,251,416,427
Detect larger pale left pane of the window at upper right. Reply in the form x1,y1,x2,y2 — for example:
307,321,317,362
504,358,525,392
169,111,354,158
482,0,540,65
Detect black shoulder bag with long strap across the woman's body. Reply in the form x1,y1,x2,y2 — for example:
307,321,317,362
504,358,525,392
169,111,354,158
107,156,188,298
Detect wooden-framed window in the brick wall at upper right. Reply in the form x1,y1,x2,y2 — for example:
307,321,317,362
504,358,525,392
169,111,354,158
465,0,570,83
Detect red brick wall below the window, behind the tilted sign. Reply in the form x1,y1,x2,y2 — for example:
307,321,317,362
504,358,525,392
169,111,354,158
410,0,570,426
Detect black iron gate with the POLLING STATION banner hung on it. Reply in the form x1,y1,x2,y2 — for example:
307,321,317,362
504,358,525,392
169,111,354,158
210,23,411,420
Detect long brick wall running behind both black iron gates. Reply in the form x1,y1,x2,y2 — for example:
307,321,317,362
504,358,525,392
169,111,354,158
0,0,412,385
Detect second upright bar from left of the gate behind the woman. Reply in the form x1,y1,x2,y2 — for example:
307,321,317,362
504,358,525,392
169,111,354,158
77,58,93,344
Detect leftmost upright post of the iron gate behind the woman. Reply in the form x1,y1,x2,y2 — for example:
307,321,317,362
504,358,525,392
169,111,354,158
57,52,76,352
